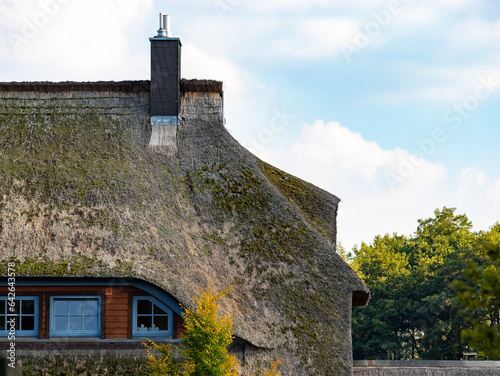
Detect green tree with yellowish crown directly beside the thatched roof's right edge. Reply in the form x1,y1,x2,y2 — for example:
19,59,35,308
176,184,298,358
351,234,410,359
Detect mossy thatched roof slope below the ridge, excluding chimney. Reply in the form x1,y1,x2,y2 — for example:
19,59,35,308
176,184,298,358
0,82,369,375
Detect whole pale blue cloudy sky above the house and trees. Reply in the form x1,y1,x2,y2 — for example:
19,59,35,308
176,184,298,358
0,0,500,250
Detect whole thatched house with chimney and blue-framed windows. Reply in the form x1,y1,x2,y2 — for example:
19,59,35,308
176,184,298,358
0,15,370,375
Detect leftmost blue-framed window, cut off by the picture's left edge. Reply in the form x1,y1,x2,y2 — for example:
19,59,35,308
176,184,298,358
0,296,39,337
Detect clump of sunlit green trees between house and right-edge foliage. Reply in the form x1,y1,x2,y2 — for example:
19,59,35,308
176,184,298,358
350,207,500,360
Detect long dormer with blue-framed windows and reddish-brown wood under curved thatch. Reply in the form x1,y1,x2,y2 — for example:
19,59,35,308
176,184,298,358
0,277,184,342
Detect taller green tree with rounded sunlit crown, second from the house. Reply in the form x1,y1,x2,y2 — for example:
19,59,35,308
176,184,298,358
410,207,478,359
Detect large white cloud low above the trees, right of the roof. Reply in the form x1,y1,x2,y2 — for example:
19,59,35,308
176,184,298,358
259,120,500,251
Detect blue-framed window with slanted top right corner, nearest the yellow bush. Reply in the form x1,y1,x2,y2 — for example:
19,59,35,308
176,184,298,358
132,296,174,338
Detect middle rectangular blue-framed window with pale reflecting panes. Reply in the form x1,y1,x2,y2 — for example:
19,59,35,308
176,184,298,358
50,295,101,337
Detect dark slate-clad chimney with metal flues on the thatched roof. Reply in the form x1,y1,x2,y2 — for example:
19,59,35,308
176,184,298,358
149,13,181,136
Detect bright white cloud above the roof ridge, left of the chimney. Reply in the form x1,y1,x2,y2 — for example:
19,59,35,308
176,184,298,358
0,0,153,80
